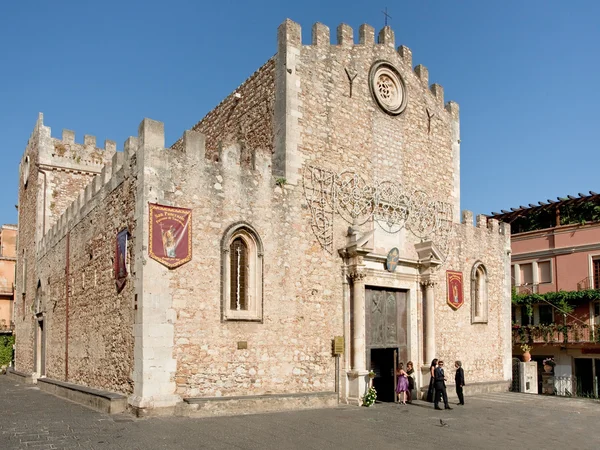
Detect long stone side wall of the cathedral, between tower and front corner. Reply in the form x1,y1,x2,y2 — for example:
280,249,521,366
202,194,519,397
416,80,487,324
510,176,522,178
17,132,136,393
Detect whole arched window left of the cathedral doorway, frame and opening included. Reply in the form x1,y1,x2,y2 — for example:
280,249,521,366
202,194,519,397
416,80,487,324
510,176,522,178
222,223,263,320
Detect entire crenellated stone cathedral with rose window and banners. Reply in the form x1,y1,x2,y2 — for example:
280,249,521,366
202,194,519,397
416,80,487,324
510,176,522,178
13,20,511,416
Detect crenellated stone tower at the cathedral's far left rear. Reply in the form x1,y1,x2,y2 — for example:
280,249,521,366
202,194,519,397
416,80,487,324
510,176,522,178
15,114,122,380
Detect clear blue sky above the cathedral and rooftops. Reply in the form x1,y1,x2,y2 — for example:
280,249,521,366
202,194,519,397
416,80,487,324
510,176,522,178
0,0,600,223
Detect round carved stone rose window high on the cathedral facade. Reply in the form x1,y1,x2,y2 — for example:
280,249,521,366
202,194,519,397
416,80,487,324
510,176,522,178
369,61,407,116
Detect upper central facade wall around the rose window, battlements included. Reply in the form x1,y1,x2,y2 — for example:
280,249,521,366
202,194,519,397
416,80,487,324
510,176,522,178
275,20,460,224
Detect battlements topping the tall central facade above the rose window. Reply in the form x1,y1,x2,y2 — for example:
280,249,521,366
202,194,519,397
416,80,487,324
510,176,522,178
278,19,458,114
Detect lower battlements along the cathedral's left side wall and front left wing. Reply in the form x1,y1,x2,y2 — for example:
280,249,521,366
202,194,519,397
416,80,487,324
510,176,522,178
37,119,271,256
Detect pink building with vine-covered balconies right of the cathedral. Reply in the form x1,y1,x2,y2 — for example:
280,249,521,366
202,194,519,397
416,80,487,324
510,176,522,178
492,191,600,397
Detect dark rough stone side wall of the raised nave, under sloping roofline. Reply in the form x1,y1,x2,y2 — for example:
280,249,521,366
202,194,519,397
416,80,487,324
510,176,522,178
172,59,275,163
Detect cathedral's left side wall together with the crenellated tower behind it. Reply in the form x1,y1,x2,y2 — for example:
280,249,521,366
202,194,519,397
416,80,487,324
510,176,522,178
16,116,136,393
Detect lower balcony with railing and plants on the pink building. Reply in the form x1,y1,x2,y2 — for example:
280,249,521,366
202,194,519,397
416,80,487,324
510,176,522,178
512,324,600,346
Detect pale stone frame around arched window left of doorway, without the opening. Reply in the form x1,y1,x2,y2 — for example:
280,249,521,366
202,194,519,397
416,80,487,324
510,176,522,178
221,222,264,322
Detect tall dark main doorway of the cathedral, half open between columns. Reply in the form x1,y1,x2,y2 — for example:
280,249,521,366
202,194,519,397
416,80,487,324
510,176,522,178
365,288,408,402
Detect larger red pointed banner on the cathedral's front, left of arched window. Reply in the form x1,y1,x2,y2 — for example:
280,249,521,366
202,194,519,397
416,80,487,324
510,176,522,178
148,203,192,269
